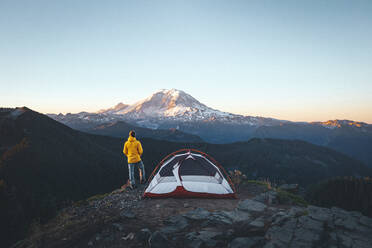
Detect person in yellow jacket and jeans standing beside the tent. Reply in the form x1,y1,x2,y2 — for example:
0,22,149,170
123,130,146,189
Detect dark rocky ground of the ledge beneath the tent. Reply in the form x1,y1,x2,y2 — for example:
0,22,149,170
15,183,372,248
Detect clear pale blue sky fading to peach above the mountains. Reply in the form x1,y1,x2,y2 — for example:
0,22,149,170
0,0,372,123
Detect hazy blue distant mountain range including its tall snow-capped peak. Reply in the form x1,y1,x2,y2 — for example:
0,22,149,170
48,89,372,167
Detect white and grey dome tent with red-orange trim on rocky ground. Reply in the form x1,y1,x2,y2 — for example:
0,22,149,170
143,149,236,198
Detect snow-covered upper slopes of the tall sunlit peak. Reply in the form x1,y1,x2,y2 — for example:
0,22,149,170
97,89,277,125
